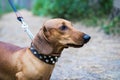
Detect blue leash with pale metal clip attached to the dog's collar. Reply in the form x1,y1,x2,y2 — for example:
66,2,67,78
8,0,34,40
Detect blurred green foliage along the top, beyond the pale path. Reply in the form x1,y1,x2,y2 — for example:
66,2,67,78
0,0,120,34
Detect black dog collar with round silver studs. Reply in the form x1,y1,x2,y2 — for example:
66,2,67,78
30,46,59,65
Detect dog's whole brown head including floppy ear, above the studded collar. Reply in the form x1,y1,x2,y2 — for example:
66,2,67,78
33,19,90,56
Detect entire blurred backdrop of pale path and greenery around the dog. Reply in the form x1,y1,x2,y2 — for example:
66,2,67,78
0,0,120,80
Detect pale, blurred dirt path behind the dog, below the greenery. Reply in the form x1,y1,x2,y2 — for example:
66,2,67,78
0,10,120,80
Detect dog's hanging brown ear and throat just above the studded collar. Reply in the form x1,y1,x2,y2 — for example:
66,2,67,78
32,30,64,56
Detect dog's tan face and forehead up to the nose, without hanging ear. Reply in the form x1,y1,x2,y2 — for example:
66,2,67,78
43,19,90,48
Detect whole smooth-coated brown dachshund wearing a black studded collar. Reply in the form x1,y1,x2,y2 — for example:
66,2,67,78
0,19,90,80
